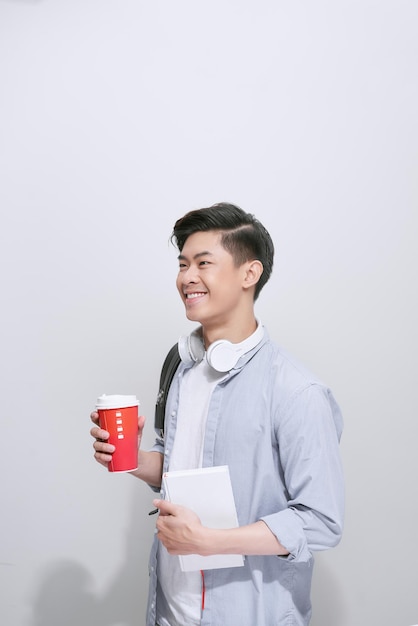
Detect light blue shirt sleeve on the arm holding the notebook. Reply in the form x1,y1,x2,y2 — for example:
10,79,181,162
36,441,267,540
261,384,344,562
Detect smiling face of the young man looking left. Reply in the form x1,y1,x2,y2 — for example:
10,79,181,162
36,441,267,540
177,231,250,330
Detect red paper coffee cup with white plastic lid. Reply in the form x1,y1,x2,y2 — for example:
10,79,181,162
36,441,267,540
96,395,139,472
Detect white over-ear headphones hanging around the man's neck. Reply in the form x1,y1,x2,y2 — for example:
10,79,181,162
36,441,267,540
178,320,264,372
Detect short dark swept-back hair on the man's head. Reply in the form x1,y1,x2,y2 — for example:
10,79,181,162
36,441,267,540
171,202,274,300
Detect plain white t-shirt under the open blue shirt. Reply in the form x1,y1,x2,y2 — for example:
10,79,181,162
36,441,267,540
157,357,226,626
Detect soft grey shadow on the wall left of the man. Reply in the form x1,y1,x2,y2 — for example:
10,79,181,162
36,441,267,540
29,488,154,626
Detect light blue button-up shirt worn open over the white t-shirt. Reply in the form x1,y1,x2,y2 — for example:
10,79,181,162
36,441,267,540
146,332,344,626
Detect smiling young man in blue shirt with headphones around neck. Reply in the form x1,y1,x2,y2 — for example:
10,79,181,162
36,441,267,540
91,203,344,626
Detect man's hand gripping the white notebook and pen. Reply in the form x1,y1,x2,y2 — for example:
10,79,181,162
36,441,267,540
153,500,209,555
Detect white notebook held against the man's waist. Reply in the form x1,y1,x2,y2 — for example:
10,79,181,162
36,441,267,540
163,465,244,572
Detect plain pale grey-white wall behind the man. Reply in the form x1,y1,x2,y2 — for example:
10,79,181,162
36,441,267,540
0,0,418,626
